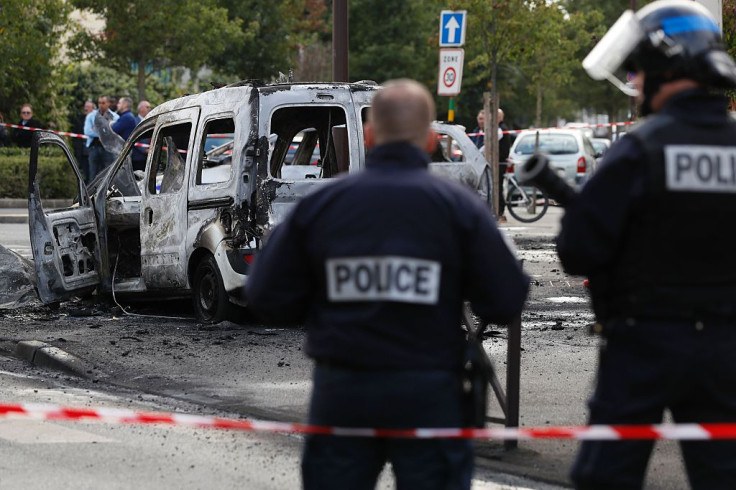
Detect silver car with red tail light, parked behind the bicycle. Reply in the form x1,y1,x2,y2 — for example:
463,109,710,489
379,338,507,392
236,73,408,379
509,129,596,187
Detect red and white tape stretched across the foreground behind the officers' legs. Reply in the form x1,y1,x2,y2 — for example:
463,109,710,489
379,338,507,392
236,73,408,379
0,403,736,441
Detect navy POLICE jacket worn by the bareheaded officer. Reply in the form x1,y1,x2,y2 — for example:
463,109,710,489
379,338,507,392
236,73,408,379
246,143,529,369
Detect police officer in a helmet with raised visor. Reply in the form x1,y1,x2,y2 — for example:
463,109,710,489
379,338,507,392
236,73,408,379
557,0,736,489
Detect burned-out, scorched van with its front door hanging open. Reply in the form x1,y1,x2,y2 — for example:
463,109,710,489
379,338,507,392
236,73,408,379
28,82,490,322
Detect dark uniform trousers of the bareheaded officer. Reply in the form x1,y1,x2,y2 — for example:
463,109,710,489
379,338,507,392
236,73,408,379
302,363,473,490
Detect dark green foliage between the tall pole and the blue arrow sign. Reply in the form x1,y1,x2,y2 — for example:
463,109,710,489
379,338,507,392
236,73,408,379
349,0,441,87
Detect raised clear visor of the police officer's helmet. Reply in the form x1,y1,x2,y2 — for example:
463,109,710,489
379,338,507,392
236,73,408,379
583,10,645,96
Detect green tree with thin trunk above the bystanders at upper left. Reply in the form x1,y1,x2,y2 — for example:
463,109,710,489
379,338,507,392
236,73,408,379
72,0,242,100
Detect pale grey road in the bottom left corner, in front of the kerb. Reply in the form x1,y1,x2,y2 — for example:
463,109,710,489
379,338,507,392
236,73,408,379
0,356,306,490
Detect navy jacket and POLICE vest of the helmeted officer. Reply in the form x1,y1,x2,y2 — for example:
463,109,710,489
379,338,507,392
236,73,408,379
557,90,736,323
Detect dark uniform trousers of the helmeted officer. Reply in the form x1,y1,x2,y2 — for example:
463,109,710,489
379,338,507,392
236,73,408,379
571,321,736,490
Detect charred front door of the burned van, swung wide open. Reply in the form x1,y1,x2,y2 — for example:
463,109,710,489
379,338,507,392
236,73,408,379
28,131,100,303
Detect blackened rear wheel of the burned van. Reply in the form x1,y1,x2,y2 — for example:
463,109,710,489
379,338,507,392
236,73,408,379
194,255,230,323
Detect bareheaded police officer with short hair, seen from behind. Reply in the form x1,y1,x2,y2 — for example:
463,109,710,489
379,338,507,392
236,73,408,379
246,80,529,490
